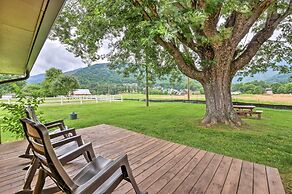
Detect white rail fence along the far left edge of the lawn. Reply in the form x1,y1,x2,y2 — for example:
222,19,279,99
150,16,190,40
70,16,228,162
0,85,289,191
0,95,123,105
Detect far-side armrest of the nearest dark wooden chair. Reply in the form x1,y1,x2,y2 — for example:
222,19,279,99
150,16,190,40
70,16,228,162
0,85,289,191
58,143,95,165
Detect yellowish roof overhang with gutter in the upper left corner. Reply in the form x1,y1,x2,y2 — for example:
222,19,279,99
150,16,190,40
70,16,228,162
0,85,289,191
0,0,65,83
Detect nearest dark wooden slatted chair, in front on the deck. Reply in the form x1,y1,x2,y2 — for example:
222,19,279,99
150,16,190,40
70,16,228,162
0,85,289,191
21,119,147,194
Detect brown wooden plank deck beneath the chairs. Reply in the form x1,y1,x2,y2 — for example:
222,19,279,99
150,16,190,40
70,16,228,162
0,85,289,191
0,125,285,194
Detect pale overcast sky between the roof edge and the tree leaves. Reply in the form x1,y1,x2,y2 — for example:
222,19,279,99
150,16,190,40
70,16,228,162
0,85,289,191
31,40,106,75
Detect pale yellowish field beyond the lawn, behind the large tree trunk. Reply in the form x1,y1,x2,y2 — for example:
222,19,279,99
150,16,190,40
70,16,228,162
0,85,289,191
123,94,292,105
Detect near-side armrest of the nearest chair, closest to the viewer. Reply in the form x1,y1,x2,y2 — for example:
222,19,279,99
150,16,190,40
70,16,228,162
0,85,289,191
77,155,130,193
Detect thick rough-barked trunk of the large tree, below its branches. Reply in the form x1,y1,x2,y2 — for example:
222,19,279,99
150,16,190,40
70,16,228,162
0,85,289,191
202,69,242,126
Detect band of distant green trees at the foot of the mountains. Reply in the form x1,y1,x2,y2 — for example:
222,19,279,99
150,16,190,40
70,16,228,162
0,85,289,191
0,68,292,97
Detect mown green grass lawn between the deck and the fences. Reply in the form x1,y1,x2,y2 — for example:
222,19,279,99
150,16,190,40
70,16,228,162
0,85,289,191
0,101,292,193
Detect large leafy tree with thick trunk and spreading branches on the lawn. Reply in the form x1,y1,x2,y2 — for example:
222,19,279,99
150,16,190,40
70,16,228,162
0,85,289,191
52,0,292,125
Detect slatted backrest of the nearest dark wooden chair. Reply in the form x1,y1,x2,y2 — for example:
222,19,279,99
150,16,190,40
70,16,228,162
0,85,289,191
21,118,77,190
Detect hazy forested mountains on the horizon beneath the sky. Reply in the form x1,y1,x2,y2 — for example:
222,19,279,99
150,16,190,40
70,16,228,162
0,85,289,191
27,63,292,85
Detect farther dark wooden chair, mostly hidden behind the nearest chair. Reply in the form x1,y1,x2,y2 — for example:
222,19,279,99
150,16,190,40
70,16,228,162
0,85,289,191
19,106,76,159
